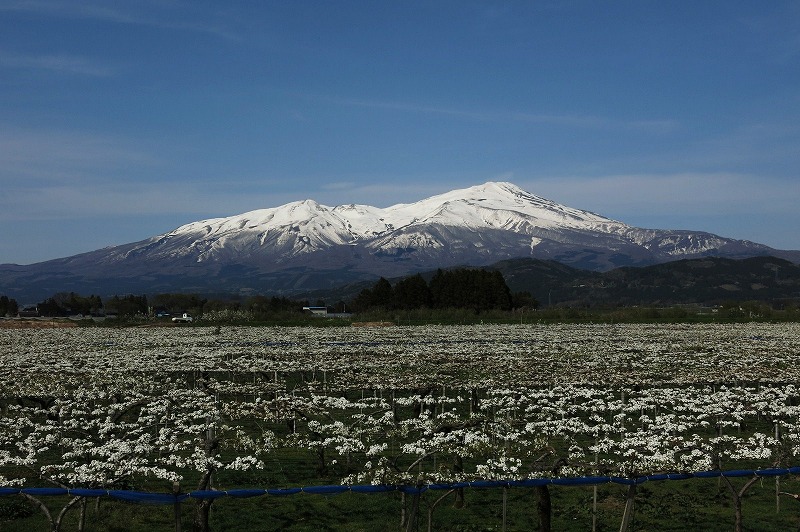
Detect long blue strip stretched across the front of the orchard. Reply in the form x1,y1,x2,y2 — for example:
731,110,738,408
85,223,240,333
0,466,800,504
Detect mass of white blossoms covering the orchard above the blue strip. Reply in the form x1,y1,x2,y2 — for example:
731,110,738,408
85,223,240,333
0,316,800,498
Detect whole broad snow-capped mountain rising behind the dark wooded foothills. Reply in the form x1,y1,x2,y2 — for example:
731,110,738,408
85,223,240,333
0,182,800,295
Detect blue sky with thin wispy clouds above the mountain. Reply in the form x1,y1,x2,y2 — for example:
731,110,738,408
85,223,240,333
0,0,800,264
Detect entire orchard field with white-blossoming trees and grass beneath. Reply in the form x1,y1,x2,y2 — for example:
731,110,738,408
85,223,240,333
0,323,800,531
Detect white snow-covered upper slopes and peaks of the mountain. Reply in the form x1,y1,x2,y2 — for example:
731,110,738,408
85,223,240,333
148,181,644,262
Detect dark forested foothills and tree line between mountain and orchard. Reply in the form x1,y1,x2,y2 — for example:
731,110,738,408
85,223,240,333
0,257,800,325
